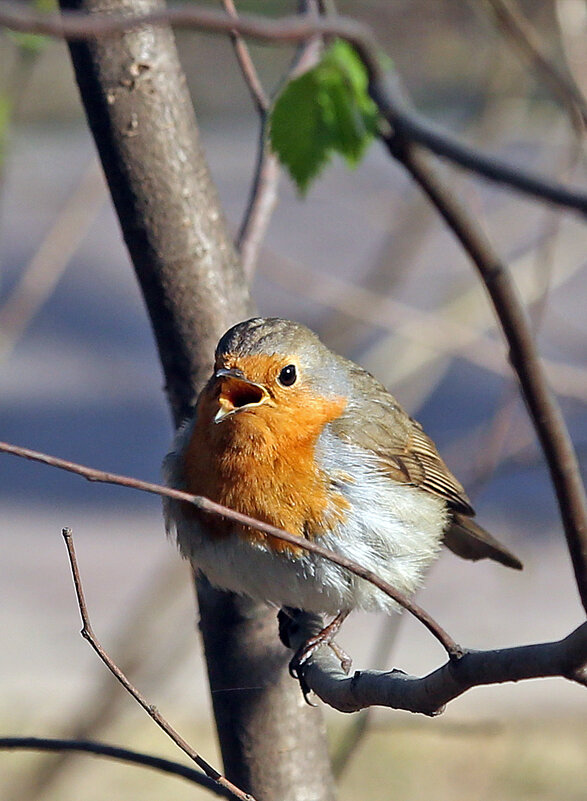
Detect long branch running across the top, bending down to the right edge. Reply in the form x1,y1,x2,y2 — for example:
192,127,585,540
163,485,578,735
0,0,587,214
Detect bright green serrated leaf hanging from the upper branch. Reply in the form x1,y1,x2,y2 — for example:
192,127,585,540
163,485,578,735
270,40,377,194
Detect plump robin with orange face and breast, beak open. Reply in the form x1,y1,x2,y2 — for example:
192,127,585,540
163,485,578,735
164,318,522,669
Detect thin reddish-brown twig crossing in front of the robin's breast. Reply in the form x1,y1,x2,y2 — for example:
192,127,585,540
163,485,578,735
0,442,463,658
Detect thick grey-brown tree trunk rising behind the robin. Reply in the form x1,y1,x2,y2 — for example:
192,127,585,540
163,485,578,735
61,0,334,801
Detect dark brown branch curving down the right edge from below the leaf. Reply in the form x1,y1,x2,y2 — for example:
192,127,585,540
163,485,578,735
378,134,587,611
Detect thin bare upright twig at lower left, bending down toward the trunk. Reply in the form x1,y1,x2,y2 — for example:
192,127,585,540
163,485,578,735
62,528,254,801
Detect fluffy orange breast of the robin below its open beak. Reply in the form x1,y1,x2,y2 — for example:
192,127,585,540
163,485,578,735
184,378,348,553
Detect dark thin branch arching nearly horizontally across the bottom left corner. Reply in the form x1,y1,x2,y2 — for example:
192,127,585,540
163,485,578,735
0,737,232,798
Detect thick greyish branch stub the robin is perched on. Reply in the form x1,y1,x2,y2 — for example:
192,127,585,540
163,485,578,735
288,614,587,715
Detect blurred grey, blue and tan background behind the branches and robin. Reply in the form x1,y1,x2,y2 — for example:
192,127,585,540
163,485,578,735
0,0,587,801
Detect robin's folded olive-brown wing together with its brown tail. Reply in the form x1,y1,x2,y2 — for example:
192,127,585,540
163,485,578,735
332,363,522,570
